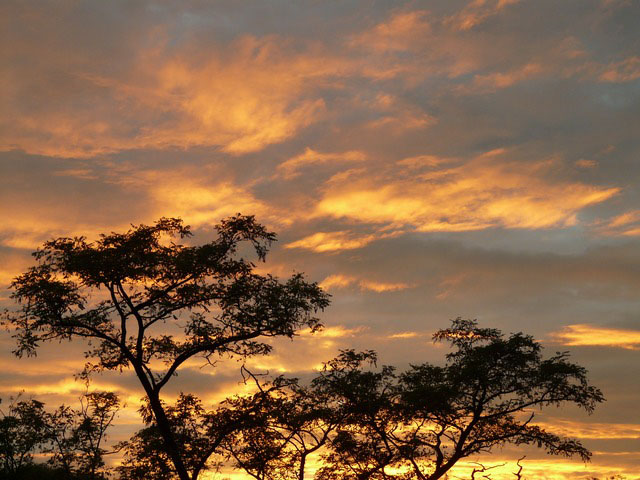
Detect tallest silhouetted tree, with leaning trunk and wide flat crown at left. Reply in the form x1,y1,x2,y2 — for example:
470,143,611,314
4,215,329,480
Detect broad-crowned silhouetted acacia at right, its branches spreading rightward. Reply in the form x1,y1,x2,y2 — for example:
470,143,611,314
314,318,604,480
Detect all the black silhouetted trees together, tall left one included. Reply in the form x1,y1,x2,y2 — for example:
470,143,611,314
0,215,604,480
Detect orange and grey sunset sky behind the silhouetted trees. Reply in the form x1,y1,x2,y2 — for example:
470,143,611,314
0,0,640,480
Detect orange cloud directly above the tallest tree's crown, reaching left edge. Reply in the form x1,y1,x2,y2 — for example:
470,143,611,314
0,164,278,249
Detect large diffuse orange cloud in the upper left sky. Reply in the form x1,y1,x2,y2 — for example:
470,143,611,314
0,36,343,158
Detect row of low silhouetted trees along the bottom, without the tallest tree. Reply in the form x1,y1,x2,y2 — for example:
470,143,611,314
0,319,602,480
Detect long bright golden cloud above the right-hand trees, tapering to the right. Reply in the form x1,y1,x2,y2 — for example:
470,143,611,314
316,151,619,232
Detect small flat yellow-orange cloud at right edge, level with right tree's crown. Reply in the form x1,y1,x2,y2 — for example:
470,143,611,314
550,324,640,350
